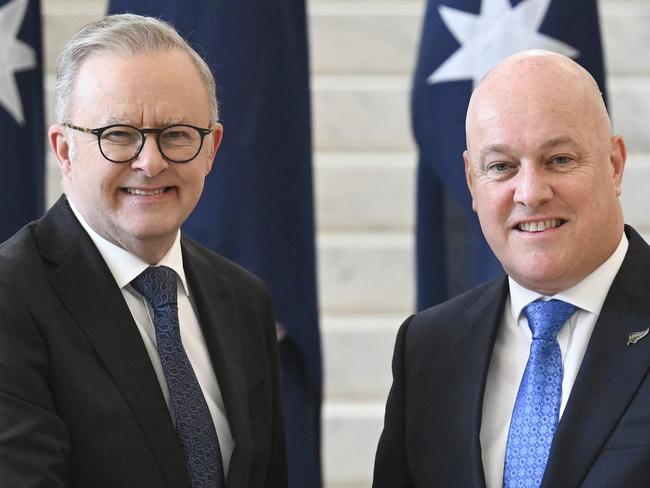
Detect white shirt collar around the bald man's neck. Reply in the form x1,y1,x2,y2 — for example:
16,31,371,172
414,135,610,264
508,233,628,322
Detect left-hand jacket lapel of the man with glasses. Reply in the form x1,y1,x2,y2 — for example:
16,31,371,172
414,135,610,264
38,198,188,486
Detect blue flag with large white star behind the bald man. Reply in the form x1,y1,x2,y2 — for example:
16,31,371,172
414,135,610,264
411,0,605,310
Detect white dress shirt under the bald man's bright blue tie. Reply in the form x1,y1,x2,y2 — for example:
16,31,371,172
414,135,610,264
480,234,628,488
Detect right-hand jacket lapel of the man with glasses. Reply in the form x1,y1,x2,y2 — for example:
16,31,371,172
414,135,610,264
182,240,251,488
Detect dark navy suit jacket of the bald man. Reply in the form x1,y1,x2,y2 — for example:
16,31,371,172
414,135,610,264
373,226,650,488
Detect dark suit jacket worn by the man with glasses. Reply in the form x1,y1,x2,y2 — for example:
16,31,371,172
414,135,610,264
0,198,288,488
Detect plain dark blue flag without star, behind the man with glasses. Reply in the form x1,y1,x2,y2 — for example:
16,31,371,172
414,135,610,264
109,0,321,488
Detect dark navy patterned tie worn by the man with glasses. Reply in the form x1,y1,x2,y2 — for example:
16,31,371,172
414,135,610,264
131,266,225,488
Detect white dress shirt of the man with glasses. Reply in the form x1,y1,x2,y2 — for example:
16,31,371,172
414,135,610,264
68,200,235,475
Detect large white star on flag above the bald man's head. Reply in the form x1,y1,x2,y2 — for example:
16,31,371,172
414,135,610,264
427,0,580,86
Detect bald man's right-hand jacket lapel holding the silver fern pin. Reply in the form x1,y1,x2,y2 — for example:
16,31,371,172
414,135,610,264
542,228,650,487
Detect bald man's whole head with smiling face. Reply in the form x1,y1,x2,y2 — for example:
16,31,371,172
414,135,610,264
464,53,625,294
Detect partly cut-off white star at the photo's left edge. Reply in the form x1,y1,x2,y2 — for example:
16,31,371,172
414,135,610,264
0,0,36,125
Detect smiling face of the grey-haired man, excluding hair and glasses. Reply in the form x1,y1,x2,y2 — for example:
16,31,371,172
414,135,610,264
50,50,222,263
